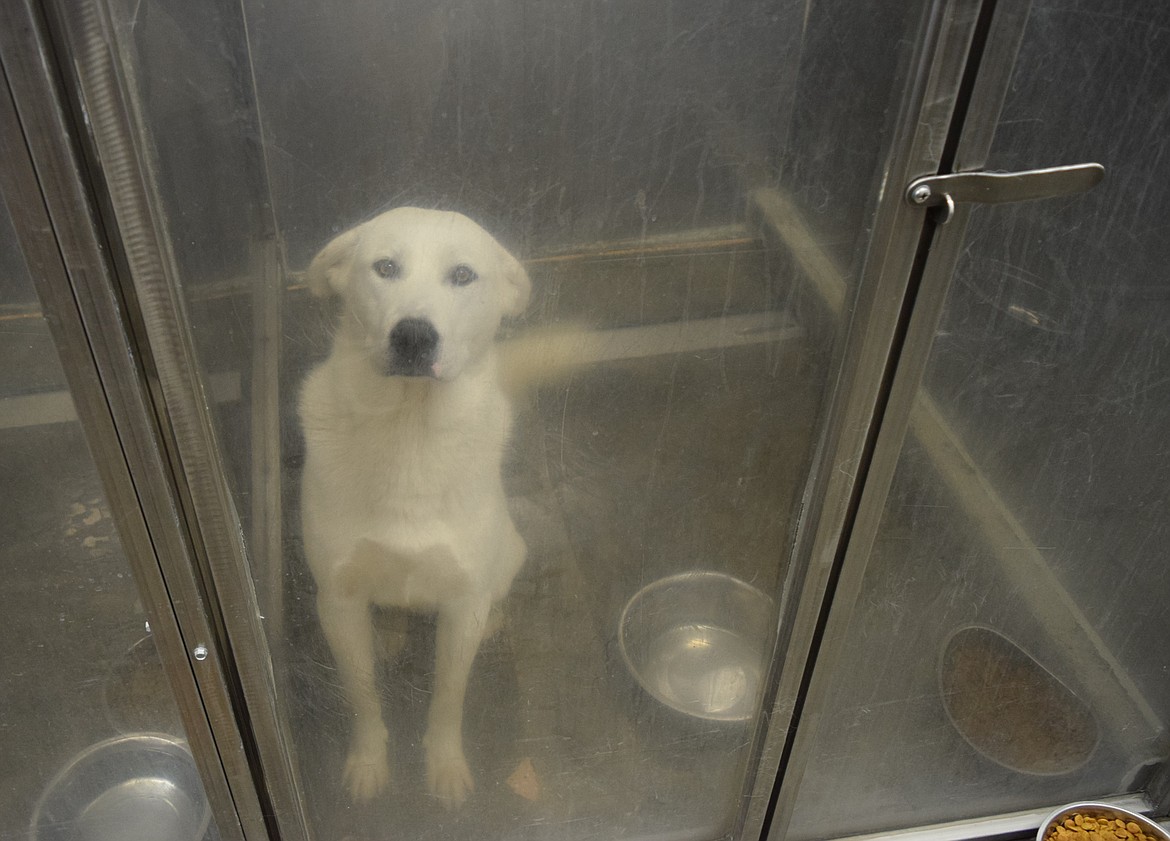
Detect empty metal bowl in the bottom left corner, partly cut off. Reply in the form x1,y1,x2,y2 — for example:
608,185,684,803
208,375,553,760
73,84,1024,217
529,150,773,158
30,733,211,841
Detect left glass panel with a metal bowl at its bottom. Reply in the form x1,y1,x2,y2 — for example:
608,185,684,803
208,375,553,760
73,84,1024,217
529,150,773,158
0,194,219,841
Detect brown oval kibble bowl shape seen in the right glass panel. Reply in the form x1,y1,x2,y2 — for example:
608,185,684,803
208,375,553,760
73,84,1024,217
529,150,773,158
938,625,1100,777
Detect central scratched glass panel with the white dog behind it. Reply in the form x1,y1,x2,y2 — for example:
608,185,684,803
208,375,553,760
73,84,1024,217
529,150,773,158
80,0,927,839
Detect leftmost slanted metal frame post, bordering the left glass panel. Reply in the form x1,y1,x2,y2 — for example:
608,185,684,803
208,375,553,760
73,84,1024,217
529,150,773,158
0,4,255,841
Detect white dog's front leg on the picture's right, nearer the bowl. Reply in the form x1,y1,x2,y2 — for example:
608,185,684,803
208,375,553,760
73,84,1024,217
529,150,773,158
424,598,491,807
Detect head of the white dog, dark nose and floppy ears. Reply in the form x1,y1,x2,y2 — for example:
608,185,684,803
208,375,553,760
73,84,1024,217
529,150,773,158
305,207,531,380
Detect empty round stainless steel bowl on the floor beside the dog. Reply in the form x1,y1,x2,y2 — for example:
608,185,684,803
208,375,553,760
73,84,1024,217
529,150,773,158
618,572,776,722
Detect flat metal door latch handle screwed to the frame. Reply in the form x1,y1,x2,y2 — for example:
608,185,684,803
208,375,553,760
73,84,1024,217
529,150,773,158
906,164,1104,225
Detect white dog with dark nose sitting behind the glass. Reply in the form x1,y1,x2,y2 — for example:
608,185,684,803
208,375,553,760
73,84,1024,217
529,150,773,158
300,207,530,806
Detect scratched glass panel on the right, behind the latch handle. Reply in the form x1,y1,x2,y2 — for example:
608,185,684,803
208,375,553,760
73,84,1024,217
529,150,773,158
791,0,1170,839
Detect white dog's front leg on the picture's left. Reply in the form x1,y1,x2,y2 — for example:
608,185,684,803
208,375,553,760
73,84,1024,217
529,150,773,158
317,591,390,801
